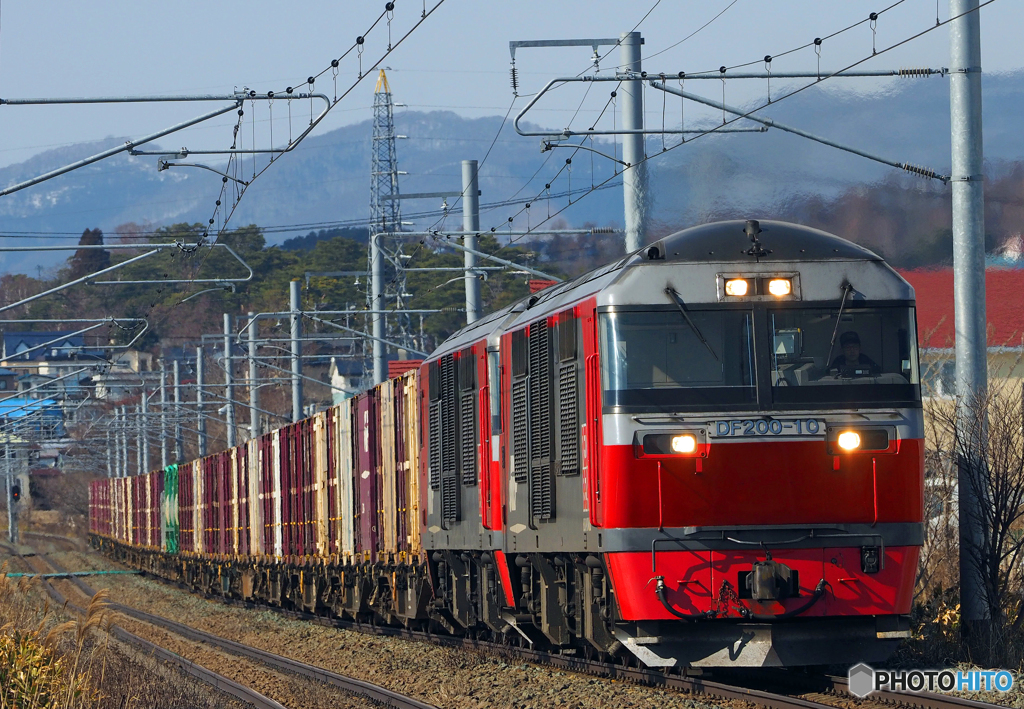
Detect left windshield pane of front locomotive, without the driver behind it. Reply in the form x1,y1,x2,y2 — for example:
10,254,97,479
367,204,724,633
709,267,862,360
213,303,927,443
600,308,757,411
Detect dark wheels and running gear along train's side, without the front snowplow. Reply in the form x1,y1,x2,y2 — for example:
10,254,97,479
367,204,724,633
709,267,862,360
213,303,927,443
91,535,623,655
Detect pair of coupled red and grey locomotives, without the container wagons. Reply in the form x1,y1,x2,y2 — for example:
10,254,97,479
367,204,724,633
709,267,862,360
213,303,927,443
421,220,924,666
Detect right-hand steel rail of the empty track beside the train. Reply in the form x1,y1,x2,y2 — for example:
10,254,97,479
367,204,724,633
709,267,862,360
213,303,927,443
45,558,437,709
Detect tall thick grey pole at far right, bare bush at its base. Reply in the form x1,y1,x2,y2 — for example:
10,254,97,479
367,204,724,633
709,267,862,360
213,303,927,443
949,0,991,639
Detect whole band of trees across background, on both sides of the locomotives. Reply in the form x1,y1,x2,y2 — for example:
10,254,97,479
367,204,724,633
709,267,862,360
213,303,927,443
0,163,1024,362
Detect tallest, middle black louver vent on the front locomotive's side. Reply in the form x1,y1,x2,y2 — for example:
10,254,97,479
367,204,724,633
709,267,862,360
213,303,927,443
529,320,554,519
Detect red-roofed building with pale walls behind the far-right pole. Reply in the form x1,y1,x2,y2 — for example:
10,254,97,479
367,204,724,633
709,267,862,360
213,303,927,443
900,267,1024,397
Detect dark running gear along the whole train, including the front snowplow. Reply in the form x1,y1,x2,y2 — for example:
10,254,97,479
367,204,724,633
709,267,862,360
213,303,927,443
91,535,909,667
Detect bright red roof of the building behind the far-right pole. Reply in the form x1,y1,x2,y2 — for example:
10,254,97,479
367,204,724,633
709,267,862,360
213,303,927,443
900,268,1024,348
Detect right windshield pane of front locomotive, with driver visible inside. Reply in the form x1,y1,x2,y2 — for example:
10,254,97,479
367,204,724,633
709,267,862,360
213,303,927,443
768,306,920,404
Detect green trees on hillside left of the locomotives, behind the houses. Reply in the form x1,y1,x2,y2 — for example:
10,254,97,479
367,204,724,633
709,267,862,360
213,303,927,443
0,224,548,350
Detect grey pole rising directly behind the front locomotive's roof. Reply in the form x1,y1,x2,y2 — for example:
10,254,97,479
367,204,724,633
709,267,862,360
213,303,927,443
618,32,647,253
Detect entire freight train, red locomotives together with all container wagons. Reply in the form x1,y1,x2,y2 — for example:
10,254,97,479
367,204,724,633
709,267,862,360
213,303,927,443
91,220,924,667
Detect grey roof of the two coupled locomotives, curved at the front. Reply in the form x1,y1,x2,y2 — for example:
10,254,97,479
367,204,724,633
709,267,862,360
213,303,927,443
428,219,883,360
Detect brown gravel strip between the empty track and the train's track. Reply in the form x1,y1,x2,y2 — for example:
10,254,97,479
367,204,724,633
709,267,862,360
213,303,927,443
54,552,752,709
